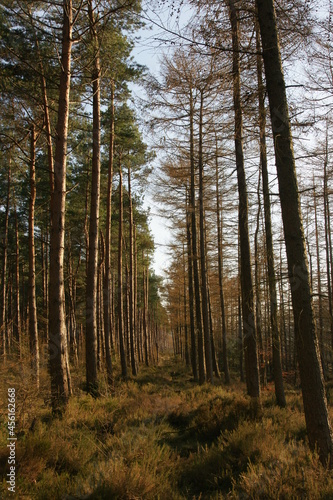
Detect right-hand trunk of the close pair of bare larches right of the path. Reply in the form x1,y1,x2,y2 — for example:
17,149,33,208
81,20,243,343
198,90,214,383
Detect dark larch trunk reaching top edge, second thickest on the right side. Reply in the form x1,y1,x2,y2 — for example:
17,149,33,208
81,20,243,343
227,0,260,402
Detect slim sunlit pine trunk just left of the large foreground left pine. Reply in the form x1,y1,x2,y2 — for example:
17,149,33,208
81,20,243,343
28,125,39,389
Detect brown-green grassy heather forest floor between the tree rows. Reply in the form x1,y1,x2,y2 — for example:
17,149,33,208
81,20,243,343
0,357,333,500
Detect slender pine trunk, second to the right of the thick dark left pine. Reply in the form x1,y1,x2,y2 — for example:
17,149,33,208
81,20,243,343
118,166,127,378
